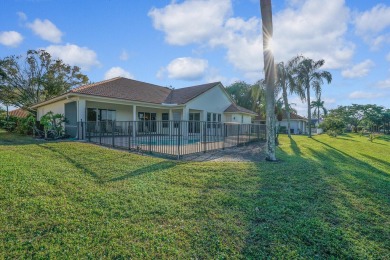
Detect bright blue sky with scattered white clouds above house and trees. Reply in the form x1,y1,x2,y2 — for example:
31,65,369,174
0,0,390,115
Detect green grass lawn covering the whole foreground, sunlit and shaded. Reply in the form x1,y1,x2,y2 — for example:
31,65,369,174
0,129,390,259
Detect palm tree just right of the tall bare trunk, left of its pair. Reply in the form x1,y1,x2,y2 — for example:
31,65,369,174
276,56,303,137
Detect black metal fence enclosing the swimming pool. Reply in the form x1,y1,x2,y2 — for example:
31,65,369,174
69,121,265,158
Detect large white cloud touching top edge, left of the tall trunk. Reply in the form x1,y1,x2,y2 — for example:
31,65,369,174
148,0,232,45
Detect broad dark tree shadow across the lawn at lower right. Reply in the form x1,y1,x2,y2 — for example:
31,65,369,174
243,139,390,259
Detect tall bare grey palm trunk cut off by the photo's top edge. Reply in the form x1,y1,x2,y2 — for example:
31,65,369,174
260,0,276,161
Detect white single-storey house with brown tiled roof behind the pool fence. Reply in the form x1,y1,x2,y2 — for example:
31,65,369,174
32,77,256,138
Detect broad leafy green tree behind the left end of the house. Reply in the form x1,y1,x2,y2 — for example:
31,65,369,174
0,50,88,111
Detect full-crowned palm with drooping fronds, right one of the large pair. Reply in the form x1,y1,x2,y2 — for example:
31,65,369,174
297,58,332,137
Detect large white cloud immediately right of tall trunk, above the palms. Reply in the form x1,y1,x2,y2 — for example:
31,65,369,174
274,0,354,69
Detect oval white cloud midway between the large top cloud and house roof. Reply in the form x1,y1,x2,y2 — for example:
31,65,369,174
163,57,208,81
